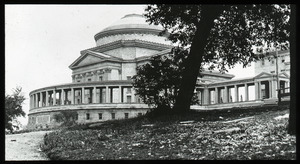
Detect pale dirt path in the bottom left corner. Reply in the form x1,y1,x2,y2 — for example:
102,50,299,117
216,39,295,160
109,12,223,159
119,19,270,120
5,131,50,161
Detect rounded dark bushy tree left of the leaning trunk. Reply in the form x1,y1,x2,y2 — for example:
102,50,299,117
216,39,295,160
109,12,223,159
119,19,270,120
133,46,198,110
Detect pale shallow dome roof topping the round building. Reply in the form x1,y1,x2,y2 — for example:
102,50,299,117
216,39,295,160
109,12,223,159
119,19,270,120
95,14,163,41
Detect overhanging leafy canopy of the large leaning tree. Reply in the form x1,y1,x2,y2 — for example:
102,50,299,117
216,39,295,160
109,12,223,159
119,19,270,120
145,4,291,71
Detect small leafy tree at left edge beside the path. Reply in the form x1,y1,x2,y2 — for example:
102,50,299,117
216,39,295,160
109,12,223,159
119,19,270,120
5,87,26,132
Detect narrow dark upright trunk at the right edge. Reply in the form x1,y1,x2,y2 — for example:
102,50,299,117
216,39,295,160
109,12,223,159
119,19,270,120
288,5,296,135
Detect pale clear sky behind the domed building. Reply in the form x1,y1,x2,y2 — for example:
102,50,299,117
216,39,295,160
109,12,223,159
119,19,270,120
5,5,254,125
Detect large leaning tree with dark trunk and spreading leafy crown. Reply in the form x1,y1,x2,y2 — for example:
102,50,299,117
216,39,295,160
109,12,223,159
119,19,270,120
145,4,291,135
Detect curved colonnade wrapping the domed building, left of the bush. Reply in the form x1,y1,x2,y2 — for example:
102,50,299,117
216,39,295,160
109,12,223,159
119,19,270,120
30,85,139,109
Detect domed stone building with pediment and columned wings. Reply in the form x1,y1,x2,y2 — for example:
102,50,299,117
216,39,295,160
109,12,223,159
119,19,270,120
27,14,289,129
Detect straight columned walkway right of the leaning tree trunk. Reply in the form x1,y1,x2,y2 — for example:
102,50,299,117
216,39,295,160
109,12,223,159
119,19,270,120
196,79,289,105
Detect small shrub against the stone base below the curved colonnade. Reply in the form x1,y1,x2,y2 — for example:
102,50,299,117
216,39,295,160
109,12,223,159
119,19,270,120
54,110,78,126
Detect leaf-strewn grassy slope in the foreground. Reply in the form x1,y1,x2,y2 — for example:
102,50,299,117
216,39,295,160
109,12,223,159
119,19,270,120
42,106,296,160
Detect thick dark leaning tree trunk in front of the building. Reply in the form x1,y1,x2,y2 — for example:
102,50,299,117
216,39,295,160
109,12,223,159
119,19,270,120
174,5,224,112
